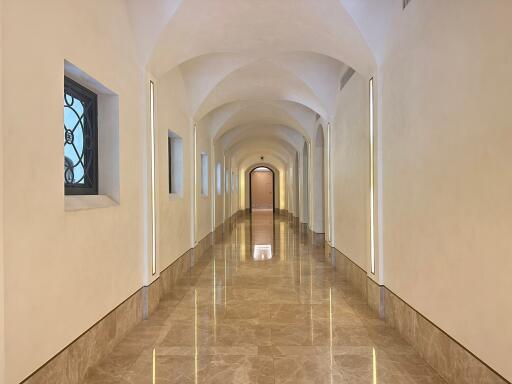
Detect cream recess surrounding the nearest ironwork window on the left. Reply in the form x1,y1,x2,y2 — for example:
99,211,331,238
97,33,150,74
61,60,120,211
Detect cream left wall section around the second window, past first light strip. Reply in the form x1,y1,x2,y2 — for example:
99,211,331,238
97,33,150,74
156,69,193,271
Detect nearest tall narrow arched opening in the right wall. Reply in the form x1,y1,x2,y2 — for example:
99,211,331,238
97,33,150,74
313,125,325,233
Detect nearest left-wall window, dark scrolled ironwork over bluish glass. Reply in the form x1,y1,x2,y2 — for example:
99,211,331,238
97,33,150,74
64,77,98,195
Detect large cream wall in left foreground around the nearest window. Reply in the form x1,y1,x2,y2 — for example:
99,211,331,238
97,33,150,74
2,0,145,384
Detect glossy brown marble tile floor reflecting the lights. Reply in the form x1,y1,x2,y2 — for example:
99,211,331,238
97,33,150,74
84,212,444,384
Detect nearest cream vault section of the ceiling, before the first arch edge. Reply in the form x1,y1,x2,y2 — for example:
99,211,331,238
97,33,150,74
137,0,375,77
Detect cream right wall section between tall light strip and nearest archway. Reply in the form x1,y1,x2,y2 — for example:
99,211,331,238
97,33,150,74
332,74,370,270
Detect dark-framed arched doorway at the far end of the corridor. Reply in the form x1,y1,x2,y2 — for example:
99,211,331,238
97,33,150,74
249,166,275,212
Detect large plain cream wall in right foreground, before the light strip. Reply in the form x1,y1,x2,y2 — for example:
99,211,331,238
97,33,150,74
380,0,512,380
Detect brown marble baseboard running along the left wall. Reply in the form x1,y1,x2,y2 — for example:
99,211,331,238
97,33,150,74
22,211,243,384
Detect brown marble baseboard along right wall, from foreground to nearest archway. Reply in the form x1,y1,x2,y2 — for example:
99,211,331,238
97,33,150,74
326,243,510,384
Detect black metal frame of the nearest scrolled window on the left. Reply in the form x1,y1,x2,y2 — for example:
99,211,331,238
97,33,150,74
63,76,99,195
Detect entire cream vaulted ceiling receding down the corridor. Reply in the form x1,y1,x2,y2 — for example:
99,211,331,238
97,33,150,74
125,0,391,170
